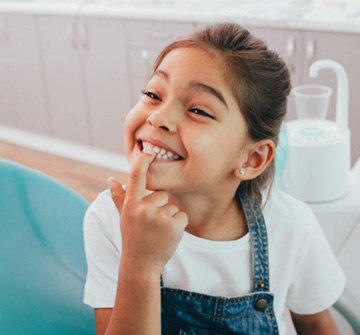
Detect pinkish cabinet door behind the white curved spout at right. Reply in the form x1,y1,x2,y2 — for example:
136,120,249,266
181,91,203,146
304,32,360,163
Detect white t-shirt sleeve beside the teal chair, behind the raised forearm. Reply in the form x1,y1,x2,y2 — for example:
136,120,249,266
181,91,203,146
84,193,121,308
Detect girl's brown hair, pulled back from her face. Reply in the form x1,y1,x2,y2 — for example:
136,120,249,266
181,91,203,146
154,23,291,205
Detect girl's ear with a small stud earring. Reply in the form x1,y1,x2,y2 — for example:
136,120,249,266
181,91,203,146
235,139,275,180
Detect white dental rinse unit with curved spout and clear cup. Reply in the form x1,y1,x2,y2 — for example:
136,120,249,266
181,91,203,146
283,60,350,202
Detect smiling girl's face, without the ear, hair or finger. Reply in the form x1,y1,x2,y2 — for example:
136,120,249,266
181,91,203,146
125,48,252,193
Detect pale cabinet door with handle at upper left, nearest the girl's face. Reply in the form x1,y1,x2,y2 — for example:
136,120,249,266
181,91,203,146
80,18,130,152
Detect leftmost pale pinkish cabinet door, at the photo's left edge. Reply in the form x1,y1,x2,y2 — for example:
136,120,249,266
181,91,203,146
2,15,49,134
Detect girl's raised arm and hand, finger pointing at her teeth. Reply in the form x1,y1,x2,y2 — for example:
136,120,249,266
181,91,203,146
95,153,188,335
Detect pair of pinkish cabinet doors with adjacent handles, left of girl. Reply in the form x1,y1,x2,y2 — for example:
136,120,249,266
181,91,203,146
38,16,130,152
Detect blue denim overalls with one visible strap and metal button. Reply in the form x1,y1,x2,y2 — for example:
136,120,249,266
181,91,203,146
161,193,279,335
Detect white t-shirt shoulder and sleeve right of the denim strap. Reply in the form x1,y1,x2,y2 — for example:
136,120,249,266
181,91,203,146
264,189,345,314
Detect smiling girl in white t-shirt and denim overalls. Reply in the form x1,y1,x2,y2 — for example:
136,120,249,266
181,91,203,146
84,24,345,335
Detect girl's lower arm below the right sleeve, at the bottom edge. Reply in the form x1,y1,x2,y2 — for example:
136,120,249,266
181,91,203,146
291,310,340,335
